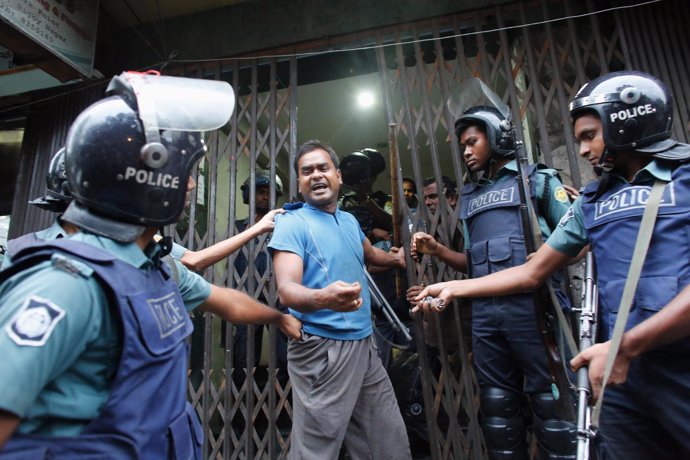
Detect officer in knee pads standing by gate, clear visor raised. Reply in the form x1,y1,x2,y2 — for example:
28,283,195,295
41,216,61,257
420,102,575,459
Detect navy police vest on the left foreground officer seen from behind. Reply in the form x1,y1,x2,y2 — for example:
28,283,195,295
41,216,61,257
0,240,203,460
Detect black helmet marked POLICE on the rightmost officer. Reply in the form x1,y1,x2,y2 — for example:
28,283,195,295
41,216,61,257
570,71,682,159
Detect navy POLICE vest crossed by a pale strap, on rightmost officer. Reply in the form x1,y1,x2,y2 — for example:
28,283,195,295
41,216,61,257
582,164,690,353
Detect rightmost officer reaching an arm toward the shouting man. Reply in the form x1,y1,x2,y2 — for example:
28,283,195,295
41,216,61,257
419,71,690,459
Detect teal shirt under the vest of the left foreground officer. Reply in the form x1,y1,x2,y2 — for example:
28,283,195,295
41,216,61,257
0,233,211,436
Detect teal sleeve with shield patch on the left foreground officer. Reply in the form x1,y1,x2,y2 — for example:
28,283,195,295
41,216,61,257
0,262,108,417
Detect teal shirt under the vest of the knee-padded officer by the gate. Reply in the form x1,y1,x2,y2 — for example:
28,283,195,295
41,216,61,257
463,160,570,250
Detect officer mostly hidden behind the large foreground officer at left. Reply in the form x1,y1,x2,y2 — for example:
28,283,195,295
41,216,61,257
2,147,78,268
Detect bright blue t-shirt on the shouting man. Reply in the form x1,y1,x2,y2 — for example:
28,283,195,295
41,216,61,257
268,204,372,340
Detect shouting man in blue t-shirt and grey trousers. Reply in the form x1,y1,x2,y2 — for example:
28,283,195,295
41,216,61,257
269,140,411,459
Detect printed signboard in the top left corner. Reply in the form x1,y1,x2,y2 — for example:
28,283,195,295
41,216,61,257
0,0,98,77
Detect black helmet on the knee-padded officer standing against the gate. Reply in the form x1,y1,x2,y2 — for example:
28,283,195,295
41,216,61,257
455,105,515,157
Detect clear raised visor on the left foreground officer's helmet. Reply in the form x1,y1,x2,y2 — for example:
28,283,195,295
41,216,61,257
122,72,235,131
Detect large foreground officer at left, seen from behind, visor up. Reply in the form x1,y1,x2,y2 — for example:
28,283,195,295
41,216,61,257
0,73,300,459
